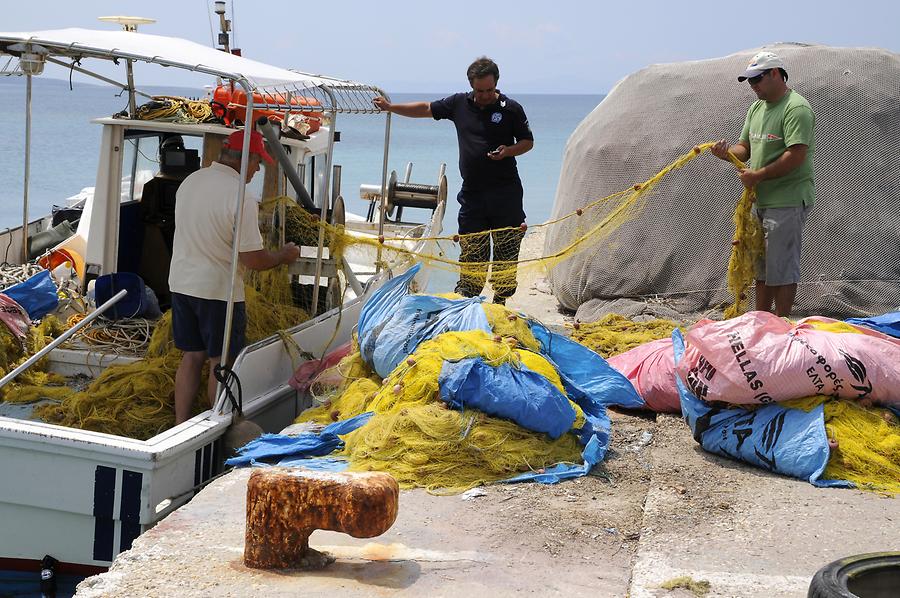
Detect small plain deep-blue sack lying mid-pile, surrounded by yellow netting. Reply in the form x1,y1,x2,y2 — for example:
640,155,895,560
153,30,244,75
438,357,575,440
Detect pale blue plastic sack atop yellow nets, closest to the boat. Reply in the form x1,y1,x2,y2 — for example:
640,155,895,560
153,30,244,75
358,264,491,378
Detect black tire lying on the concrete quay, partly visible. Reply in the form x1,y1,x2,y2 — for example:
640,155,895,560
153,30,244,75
807,552,900,598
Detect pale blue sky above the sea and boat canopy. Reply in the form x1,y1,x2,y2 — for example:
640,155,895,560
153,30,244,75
0,0,900,94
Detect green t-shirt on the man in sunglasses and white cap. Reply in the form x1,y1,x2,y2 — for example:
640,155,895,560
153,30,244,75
741,90,816,208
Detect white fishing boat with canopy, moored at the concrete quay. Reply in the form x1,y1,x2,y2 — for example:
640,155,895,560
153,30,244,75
0,12,446,574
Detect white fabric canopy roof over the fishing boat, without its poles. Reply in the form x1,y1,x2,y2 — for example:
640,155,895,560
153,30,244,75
0,28,379,112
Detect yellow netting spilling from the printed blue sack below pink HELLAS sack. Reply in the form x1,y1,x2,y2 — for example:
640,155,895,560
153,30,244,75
781,395,900,495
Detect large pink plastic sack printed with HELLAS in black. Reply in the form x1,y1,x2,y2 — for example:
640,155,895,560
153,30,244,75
676,311,900,405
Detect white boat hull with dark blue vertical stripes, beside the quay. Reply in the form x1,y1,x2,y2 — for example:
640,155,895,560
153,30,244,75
0,282,379,572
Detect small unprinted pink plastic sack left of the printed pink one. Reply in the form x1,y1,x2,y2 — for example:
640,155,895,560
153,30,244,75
606,338,681,413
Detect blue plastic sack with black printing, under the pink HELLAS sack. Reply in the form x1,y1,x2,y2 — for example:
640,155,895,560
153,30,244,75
672,330,853,487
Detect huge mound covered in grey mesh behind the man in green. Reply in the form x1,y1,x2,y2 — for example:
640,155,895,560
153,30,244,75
545,44,900,319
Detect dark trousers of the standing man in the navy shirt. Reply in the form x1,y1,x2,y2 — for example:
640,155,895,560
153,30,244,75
456,181,525,303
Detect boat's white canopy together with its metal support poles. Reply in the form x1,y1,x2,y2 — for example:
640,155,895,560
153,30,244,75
0,28,391,404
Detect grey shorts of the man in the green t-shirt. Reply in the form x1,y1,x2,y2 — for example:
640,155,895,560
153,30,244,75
756,206,809,287
